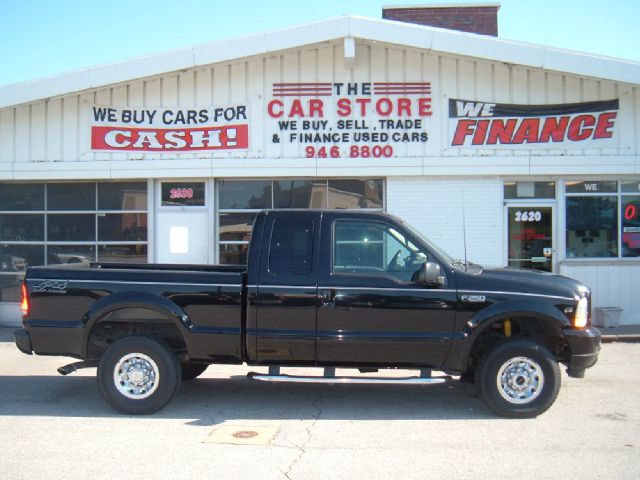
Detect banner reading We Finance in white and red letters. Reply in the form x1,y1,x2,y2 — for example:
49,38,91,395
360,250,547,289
449,99,619,150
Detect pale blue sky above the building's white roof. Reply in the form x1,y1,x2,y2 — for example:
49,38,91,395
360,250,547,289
0,0,640,85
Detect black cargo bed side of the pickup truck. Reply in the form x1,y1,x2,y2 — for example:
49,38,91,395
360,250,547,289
26,263,246,363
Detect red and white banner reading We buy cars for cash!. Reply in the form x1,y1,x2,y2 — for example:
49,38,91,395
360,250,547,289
91,105,249,153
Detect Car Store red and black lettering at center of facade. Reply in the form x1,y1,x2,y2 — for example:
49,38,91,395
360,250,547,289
266,82,433,158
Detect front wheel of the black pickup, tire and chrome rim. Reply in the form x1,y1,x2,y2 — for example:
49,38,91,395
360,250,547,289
476,339,561,418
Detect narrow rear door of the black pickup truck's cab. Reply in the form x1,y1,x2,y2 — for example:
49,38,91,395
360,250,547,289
247,211,321,365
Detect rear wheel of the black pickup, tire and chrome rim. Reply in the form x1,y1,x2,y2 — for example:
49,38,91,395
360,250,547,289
98,336,181,415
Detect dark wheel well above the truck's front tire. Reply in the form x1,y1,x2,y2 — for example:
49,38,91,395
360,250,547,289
467,316,567,371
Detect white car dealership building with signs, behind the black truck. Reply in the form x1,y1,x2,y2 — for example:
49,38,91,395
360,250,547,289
0,4,640,325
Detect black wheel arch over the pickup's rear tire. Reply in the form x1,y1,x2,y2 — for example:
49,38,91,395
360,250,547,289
87,308,188,360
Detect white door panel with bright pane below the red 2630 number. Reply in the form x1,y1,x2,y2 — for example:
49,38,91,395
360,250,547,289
157,211,211,264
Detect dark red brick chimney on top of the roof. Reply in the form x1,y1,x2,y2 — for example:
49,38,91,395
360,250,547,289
382,3,500,37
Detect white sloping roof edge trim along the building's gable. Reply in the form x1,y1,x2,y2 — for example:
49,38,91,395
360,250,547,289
0,16,640,108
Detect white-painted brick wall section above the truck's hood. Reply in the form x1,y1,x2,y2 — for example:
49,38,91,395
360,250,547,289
387,177,504,266
